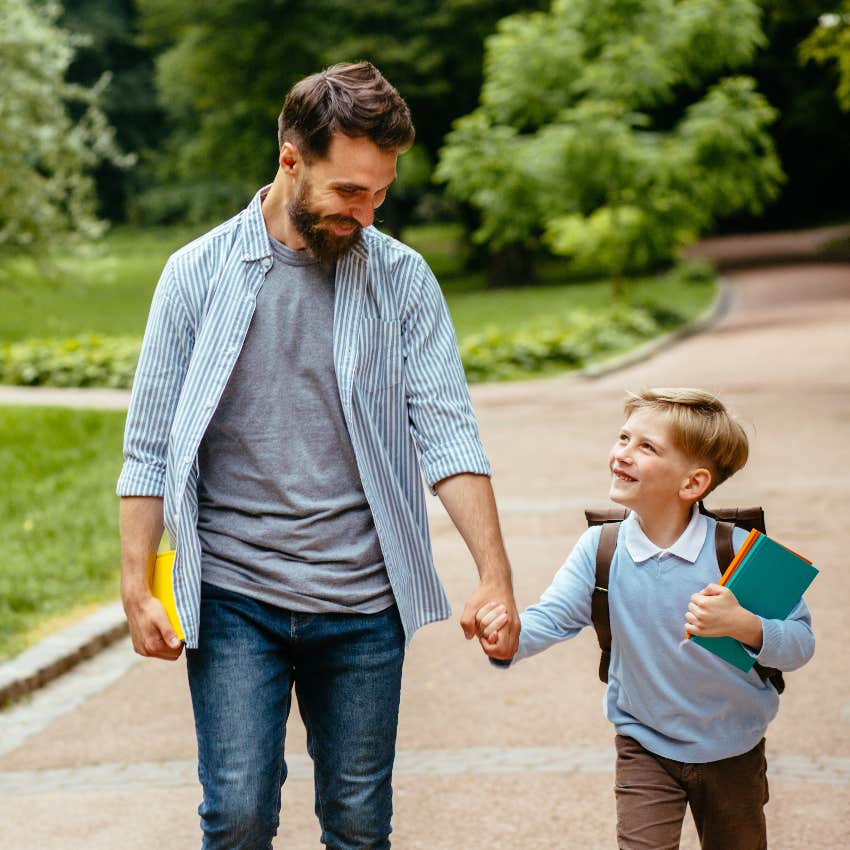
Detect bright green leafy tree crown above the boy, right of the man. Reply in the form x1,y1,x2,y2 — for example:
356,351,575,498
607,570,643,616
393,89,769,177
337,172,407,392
437,0,782,280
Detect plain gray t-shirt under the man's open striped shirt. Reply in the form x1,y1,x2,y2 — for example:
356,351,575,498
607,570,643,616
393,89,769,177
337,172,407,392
198,239,393,613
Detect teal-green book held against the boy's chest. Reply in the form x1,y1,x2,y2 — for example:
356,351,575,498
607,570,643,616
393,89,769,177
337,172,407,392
691,534,818,672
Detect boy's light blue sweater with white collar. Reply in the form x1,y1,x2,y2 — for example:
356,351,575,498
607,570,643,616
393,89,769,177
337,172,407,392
512,511,815,763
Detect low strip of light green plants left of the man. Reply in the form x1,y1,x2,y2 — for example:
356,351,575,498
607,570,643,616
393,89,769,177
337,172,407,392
0,336,140,388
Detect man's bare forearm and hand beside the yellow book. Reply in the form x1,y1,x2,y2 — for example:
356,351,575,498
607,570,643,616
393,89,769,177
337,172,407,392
119,496,183,661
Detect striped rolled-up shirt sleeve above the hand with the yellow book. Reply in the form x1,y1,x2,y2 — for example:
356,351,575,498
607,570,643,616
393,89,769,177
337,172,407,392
116,261,194,496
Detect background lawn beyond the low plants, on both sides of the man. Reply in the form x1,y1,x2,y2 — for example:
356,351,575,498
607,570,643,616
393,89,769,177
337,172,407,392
0,224,714,352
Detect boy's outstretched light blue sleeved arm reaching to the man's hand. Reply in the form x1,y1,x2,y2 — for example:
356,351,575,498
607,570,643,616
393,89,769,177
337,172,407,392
483,526,599,666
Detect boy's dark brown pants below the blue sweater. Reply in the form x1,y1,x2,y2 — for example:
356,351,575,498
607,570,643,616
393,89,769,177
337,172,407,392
615,735,768,850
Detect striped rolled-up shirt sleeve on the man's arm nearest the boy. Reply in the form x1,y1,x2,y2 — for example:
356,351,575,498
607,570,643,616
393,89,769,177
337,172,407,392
402,260,490,492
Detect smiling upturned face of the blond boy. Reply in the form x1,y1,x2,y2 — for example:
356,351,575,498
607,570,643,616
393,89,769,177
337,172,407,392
608,410,699,515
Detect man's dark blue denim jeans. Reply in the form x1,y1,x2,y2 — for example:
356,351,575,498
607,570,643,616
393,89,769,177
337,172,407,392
186,584,404,850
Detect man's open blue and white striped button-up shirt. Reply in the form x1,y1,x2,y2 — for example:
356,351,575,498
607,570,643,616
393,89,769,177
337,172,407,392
117,190,490,648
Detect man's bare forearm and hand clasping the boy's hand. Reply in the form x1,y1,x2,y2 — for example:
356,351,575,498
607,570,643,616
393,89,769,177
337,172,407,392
435,473,519,659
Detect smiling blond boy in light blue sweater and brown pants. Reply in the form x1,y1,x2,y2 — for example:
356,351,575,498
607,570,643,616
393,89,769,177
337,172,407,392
477,389,815,850
